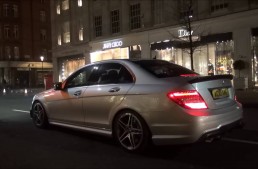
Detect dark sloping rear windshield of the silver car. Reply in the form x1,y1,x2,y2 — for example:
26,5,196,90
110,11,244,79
133,60,198,78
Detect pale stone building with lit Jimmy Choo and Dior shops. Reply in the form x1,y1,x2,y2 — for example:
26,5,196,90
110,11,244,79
51,0,258,88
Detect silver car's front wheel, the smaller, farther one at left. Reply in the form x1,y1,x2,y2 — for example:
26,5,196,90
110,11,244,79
32,102,49,128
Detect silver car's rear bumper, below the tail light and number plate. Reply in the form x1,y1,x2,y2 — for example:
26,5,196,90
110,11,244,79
151,101,243,145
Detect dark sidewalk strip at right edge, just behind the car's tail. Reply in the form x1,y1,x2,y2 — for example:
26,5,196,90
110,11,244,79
235,89,258,107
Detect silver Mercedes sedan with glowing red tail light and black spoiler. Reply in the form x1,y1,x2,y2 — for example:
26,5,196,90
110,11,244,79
30,60,243,152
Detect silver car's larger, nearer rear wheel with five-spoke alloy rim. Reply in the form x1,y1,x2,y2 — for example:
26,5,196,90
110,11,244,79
113,111,150,152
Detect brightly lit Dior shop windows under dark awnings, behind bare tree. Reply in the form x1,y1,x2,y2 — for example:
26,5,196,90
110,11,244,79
151,33,234,75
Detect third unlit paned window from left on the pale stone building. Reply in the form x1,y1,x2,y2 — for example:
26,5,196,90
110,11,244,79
130,3,141,29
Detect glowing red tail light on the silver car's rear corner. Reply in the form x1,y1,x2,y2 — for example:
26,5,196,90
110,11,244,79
168,90,207,109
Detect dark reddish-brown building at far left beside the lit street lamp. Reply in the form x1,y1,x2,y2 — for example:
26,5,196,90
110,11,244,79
0,0,53,88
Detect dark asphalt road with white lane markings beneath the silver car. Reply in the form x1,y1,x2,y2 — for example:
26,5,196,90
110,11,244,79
0,94,258,169
